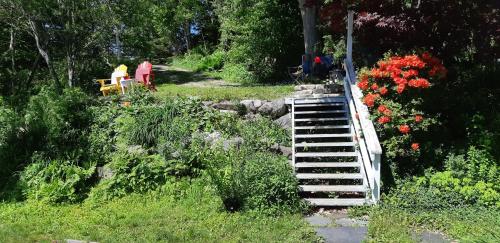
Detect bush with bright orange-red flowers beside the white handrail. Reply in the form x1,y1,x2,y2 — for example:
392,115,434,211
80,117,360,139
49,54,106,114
357,52,447,158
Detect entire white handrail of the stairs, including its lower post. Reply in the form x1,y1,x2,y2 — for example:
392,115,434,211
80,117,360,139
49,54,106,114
344,59,382,203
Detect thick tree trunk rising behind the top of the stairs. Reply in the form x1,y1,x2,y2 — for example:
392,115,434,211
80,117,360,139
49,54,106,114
298,0,318,73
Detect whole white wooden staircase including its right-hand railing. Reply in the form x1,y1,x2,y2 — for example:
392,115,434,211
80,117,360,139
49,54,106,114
288,59,382,206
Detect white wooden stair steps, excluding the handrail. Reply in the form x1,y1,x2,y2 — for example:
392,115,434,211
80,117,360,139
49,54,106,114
293,97,366,206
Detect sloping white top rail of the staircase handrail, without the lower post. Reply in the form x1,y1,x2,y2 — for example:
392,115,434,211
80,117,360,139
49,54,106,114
344,60,382,158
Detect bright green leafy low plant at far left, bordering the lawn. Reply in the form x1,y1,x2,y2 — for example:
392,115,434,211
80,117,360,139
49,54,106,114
20,160,95,203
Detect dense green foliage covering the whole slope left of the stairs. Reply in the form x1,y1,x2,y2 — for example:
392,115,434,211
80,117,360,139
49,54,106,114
0,88,304,214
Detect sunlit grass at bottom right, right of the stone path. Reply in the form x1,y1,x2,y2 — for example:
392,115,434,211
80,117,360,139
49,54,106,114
368,207,500,242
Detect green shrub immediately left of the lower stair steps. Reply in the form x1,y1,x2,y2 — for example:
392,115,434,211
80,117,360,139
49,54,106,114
204,146,304,214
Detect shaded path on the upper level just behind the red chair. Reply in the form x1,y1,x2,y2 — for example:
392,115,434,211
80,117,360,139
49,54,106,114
153,64,239,87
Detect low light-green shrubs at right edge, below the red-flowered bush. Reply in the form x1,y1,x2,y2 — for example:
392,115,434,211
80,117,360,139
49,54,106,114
387,147,500,209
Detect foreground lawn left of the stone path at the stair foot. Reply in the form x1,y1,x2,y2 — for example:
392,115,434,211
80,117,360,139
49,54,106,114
0,190,317,242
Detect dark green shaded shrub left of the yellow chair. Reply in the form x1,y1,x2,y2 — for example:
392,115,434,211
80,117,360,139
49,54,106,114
24,88,92,159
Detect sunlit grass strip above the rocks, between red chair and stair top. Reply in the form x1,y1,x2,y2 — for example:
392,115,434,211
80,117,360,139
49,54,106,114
156,84,293,101
